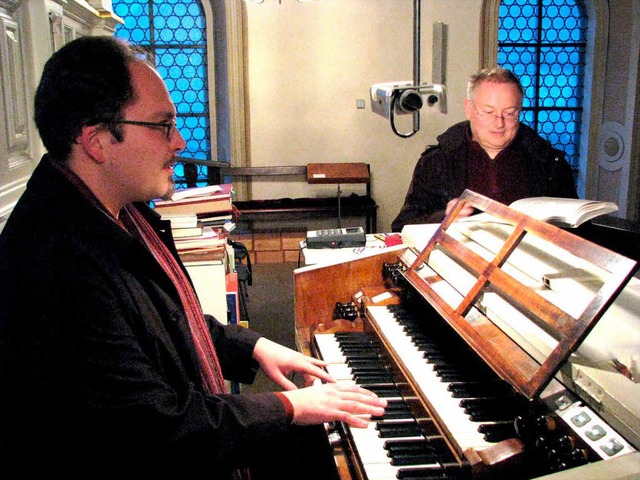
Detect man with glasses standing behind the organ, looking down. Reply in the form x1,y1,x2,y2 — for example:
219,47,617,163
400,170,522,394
391,67,577,232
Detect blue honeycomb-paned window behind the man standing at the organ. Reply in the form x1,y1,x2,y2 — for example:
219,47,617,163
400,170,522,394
498,0,588,170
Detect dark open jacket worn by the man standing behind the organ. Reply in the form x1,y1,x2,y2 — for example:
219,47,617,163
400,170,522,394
391,121,577,232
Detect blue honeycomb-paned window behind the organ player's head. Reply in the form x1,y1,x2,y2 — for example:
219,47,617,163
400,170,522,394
113,0,212,188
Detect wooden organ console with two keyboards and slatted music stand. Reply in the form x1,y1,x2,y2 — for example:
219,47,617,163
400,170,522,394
294,190,640,480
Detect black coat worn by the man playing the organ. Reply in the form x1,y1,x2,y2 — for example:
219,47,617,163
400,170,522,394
0,158,290,478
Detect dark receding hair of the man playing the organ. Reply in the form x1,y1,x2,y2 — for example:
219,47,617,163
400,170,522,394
34,36,153,162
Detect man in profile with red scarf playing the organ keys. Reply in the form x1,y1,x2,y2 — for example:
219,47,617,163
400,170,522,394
0,37,386,480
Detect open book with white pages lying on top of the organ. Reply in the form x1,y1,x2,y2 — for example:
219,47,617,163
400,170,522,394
459,197,618,228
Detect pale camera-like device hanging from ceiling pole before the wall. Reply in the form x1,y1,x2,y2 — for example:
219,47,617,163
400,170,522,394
371,82,447,119
